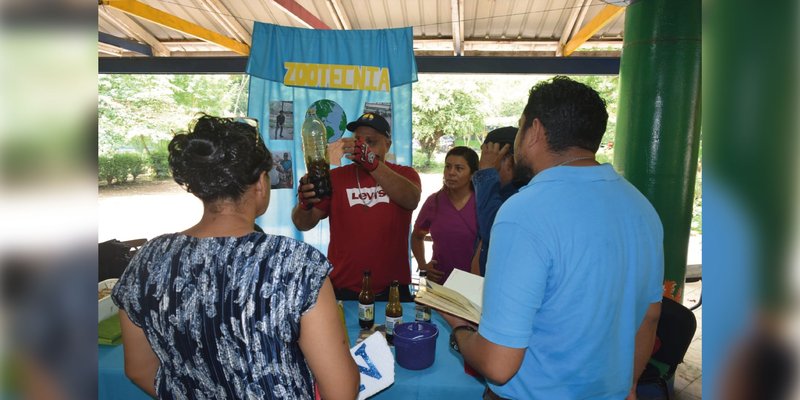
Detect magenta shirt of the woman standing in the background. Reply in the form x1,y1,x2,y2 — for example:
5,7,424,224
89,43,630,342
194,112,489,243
414,192,478,279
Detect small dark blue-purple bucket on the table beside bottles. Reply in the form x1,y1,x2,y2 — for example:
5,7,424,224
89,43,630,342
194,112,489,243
394,322,439,369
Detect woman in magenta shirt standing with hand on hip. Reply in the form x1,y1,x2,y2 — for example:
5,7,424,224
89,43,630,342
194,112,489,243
411,146,478,283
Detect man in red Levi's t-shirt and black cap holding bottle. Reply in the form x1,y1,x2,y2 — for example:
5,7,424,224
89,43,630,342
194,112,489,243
292,113,421,301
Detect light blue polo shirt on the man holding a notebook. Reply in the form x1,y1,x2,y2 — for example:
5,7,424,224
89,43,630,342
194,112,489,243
479,164,664,400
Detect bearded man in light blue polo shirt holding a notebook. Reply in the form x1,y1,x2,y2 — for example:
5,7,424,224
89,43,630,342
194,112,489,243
445,77,664,400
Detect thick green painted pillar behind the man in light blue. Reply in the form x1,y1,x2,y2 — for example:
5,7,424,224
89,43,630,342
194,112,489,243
614,0,701,302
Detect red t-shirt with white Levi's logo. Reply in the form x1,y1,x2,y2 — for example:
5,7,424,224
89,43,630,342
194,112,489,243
317,163,420,293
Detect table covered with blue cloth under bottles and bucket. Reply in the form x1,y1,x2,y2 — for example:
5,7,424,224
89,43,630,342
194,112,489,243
98,301,484,400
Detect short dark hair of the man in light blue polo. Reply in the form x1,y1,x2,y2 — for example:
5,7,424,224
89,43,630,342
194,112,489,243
523,76,608,153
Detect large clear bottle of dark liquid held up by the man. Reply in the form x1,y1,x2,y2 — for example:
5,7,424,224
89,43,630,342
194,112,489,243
301,111,331,198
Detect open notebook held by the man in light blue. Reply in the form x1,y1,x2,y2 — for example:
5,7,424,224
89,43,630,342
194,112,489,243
414,269,483,324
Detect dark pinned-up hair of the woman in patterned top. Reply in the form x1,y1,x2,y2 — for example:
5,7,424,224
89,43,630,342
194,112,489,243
168,114,272,203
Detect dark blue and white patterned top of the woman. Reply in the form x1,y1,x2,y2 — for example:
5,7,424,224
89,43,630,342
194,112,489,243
112,232,331,400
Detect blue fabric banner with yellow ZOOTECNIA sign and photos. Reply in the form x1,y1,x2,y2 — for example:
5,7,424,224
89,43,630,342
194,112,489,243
247,22,417,253
